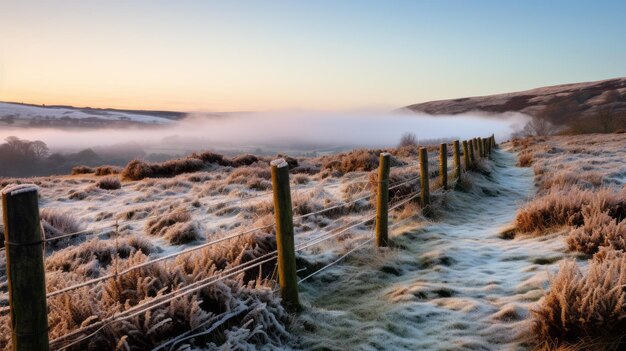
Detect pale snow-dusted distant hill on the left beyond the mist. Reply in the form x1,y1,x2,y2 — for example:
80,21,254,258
0,102,186,127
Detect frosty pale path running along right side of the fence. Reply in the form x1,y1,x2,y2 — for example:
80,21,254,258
300,151,566,350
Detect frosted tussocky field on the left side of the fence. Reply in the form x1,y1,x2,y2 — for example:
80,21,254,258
0,146,436,350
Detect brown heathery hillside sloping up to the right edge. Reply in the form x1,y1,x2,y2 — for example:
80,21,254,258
405,78,626,125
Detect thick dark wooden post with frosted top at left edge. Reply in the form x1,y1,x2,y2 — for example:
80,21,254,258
2,184,49,351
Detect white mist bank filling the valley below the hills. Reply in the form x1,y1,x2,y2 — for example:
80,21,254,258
0,112,528,149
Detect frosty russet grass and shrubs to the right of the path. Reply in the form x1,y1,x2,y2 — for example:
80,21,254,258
504,134,626,350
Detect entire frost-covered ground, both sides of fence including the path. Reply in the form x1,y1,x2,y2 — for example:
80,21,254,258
0,134,626,350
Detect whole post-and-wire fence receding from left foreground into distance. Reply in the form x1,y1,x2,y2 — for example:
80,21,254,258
0,135,496,350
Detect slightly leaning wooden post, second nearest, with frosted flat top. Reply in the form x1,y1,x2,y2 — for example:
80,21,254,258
271,159,300,311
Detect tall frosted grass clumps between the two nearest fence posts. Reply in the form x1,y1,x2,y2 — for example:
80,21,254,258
0,231,290,350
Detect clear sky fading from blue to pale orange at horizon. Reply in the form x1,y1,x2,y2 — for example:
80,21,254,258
0,0,626,111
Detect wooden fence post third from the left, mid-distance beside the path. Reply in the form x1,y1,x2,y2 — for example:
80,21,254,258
376,152,391,247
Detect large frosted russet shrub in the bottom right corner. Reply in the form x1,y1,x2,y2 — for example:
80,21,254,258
531,251,626,349
